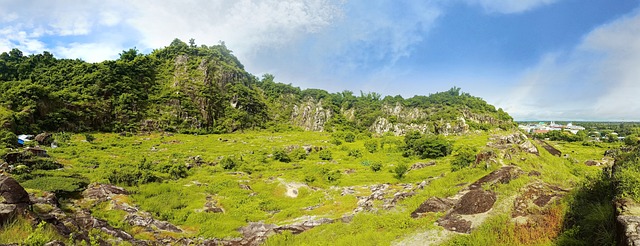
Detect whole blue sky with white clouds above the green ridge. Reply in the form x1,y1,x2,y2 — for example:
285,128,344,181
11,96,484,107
0,0,640,121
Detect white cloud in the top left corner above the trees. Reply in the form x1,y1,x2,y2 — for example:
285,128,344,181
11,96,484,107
0,0,127,58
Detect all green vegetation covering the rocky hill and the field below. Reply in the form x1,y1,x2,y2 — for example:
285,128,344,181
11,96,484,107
0,39,640,245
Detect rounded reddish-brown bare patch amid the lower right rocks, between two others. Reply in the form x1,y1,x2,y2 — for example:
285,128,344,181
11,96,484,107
453,190,497,214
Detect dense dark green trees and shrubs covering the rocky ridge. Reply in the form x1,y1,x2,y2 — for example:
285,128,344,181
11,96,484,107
0,39,513,136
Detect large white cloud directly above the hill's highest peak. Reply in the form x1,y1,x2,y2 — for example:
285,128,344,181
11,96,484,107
128,0,341,54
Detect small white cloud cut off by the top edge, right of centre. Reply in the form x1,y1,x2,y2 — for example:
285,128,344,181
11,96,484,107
465,0,559,14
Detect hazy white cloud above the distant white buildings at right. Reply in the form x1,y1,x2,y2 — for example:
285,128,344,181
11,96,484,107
505,12,640,120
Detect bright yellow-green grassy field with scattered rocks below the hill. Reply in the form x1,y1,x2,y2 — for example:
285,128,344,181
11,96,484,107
2,132,607,245
